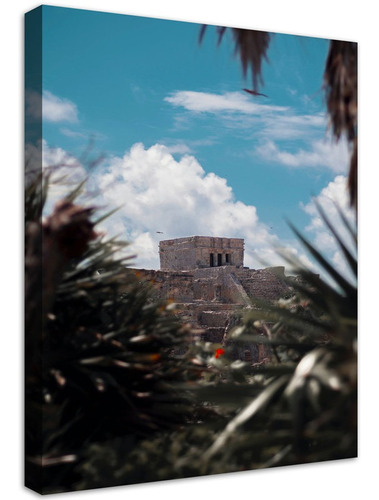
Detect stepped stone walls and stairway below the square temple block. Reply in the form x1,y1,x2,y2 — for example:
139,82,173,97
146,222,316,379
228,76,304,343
130,266,292,354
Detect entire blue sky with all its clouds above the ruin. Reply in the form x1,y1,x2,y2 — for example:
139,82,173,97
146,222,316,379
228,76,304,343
27,6,356,274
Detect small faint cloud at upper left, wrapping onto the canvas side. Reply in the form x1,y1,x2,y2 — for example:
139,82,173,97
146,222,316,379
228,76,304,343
25,90,78,123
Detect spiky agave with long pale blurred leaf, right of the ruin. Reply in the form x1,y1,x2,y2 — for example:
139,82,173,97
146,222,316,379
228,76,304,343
197,201,357,471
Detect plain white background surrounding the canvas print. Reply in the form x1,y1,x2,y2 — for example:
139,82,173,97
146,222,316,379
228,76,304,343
0,0,379,500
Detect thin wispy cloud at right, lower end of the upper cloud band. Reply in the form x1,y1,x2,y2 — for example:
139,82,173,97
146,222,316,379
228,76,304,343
255,138,349,173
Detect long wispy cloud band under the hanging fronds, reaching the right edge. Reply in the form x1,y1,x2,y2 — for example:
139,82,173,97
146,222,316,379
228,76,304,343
165,90,349,173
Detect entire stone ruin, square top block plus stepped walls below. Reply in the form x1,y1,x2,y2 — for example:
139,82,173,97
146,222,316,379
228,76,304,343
134,236,296,363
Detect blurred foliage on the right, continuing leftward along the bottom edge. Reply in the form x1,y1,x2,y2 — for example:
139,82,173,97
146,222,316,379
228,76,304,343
72,199,357,488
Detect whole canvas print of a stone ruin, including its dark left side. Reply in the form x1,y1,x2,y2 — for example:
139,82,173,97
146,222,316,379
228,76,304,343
25,6,358,494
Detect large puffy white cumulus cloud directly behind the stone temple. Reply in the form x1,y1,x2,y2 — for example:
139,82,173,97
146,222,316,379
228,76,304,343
88,144,296,268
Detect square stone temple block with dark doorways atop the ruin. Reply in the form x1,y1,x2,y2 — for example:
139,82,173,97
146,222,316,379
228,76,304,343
159,236,244,271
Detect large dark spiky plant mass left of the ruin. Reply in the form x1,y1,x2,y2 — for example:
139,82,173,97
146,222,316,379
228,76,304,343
25,174,211,492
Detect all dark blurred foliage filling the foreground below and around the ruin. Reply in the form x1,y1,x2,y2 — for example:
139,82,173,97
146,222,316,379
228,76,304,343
26,172,357,493
